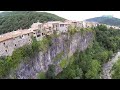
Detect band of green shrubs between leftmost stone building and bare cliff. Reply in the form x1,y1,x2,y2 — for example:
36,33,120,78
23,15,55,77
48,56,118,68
0,35,56,78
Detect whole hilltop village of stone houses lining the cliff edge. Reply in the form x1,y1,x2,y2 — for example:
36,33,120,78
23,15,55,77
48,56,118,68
0,20,120,56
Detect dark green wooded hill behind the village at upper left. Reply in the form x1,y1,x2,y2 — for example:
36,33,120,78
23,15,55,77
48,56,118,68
0,11,65,34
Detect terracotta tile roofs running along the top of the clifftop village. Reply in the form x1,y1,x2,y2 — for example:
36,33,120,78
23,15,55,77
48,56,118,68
0,20,102,42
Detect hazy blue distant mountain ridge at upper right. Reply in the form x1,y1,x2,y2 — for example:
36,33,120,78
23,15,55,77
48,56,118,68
85,15,120,26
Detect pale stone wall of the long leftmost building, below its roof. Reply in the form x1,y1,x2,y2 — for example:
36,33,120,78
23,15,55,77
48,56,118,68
0,34,32,56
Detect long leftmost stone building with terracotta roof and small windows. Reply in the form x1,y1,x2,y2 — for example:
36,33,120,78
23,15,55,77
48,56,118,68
0,30,33,56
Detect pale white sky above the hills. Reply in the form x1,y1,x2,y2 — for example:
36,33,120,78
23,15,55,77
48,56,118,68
0,11,120,21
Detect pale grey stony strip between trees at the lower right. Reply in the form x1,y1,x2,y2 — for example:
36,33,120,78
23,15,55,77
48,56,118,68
102,52,120,79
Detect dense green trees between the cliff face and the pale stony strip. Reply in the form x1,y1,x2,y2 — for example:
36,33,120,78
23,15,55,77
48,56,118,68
56,25,120,79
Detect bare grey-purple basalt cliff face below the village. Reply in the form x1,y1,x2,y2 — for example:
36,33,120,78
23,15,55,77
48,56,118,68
9,32,94,79
